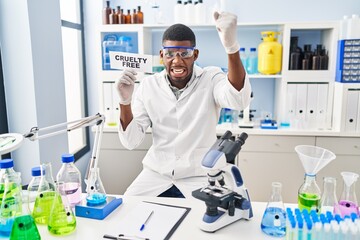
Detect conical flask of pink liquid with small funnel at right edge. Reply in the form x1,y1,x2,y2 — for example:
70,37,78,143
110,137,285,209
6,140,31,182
339,172,359,217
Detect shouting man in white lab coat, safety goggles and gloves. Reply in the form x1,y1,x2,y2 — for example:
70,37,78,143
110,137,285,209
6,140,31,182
116,12,251,197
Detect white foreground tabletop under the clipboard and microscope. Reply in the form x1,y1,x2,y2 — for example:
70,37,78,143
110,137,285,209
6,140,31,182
6,195,295,240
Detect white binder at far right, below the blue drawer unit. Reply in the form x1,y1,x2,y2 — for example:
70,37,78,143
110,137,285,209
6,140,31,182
345,89,359,132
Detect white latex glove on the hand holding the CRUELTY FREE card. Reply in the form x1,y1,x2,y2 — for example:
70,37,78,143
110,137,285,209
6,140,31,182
115,69,137,105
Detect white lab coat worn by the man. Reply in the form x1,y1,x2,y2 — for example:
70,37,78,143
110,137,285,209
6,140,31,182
119,66,251,197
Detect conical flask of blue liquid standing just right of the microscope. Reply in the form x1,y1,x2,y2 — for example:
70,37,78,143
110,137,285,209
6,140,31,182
261,182,286,237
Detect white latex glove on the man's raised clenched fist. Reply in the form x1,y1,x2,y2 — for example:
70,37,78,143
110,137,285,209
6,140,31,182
214,12,240,54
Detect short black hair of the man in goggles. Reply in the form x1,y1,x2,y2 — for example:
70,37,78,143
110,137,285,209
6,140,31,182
162,23,196,47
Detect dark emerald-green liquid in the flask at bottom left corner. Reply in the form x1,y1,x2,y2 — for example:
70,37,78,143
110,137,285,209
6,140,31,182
10,215,41,240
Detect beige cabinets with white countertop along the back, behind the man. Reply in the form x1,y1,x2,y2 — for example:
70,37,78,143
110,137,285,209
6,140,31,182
99,126,360,203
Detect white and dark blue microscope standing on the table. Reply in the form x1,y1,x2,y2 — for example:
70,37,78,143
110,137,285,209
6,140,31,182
192,131,253,232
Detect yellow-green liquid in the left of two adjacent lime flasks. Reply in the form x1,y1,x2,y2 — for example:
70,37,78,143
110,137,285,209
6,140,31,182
32,191,55,224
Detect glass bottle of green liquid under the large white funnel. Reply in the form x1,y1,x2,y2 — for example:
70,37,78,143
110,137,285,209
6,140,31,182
298,174,321,212
